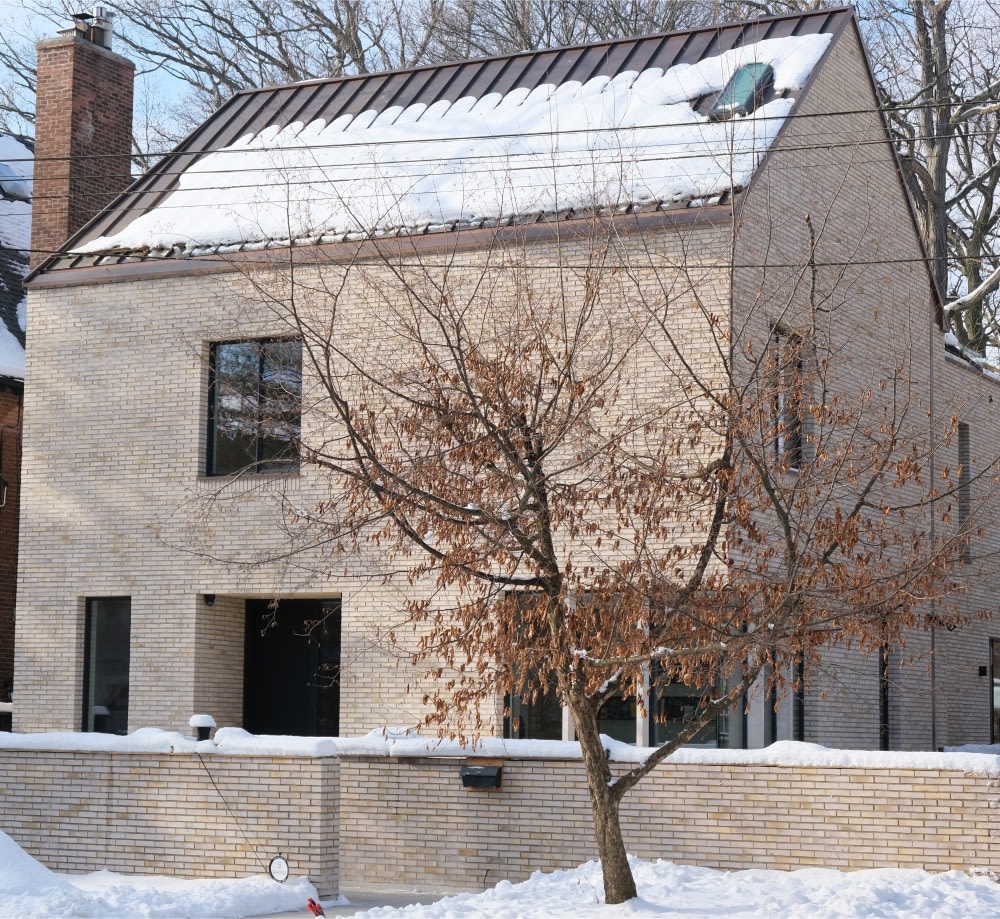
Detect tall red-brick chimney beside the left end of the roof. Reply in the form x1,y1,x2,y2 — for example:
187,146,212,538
31,7,135,267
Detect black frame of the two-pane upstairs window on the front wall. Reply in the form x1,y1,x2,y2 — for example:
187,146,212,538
204,336,302,478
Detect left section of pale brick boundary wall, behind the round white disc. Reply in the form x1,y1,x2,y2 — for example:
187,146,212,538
0,750,339,896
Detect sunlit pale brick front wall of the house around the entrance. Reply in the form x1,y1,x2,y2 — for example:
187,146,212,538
14,221,728,734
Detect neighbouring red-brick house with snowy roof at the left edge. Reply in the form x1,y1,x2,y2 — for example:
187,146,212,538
0,131,32,712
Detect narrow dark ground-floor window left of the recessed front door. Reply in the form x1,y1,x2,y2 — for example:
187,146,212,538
83,597,132,734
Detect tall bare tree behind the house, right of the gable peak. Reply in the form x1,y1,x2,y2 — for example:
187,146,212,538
867,0,1000,357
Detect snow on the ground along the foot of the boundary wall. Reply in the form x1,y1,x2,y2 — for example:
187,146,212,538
0,833,1000,919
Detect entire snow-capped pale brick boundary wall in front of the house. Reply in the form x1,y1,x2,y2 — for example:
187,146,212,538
0,729,1000,896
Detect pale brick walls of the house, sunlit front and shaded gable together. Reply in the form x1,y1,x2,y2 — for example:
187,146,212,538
15,14,1000,748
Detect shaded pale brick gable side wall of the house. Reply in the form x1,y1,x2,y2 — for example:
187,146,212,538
733,16,1000,749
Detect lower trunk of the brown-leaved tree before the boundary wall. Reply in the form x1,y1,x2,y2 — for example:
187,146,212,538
571,699,638,904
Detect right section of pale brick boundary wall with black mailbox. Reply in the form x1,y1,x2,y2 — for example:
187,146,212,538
340,756,1000,890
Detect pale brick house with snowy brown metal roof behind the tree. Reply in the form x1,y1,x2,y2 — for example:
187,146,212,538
15,10,1000,748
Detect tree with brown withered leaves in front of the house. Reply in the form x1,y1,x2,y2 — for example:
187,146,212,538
215,199,963,903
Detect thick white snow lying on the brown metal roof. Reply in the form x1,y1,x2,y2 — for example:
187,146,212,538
75,34,832,254
